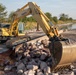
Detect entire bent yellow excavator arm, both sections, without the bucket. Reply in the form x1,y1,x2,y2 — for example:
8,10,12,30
10,2,58,38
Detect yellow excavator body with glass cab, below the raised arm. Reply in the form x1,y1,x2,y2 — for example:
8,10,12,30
0,21,25,43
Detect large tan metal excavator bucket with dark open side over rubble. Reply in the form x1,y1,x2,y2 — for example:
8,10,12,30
49,34,76,71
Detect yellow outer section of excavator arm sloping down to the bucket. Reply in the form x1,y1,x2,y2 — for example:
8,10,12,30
28,2,58,38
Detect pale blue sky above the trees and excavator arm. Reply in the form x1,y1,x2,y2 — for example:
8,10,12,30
0,0,76,19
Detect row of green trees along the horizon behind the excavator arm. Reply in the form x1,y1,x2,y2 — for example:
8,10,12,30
0,4,73,24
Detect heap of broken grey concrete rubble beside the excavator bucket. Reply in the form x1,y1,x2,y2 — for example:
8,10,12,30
0,39,73,75
